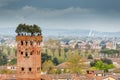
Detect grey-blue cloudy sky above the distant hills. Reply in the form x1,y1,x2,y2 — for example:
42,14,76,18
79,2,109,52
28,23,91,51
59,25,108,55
0,0,120,32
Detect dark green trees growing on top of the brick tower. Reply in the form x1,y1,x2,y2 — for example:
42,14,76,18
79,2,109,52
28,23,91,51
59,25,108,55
15,24,42,35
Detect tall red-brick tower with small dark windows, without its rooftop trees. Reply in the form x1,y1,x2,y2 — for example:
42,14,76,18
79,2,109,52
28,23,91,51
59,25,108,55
16,35,42,80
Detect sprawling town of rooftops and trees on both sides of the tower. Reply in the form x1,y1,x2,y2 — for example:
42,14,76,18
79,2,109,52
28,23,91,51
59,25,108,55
0,32,120,80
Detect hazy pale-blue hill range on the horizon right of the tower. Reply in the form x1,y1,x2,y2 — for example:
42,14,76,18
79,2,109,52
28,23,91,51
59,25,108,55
43,29,120,37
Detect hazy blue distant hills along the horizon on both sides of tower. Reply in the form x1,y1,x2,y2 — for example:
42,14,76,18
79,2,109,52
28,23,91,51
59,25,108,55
0,28,120,37
